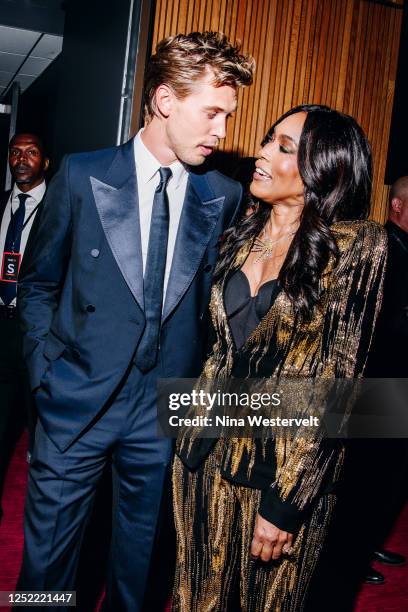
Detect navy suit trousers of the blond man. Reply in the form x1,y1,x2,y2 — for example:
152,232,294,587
17,366,171,612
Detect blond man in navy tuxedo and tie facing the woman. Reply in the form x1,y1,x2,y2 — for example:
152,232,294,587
17,32,253,612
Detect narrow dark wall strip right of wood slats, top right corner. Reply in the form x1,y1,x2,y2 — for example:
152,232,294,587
385,0,408,185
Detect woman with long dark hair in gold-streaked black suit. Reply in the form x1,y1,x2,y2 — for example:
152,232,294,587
173,105,386,612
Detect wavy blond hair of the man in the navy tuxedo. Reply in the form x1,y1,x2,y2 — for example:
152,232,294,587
144,32,255,120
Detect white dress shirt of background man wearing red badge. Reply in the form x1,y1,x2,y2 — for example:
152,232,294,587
0,181,46,306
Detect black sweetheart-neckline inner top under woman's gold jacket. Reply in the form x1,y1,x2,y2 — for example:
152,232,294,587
224,270,279,349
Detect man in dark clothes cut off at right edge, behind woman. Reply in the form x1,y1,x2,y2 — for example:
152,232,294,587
363,176,408,584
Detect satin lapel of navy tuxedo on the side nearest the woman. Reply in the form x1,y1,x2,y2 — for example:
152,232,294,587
163,179,225,320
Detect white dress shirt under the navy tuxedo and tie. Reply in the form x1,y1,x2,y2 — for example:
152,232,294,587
134,129,188,296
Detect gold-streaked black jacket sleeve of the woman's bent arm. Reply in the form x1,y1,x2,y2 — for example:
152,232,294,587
259,222,387,533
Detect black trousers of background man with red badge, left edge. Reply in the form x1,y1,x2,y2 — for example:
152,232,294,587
0,318,34,518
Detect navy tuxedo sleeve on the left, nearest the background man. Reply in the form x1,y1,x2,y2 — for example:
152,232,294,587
17,157,72,390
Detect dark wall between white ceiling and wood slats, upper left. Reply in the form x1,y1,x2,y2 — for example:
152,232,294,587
17,0,135,167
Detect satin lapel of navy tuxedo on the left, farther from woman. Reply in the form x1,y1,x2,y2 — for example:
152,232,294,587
91,172,144,310
